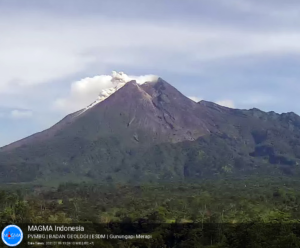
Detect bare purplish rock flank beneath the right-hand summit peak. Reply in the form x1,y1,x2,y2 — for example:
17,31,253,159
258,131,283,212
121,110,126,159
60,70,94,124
141,79,210,143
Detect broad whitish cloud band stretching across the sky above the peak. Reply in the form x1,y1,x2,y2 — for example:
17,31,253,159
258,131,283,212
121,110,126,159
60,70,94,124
0,9,300,95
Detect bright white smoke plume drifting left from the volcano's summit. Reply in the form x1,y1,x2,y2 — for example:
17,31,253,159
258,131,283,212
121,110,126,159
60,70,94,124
54,71,158,113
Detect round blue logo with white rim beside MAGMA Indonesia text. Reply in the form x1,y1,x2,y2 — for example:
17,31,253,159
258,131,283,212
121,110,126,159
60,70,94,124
1,225,23,247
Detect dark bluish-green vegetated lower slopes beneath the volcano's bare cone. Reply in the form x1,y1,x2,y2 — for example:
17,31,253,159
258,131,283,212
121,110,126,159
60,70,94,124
0,127,300,184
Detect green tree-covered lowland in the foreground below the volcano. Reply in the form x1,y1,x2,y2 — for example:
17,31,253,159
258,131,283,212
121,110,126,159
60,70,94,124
0,177,300,247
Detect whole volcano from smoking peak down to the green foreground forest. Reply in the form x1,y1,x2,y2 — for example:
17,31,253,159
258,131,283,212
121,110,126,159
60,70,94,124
0,73,300,182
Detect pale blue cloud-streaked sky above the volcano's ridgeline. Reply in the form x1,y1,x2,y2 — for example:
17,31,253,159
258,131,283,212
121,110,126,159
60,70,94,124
0,0,300,146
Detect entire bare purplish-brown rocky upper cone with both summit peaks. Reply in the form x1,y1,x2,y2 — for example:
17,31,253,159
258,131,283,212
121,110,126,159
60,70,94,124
71,79,209,144
